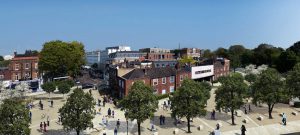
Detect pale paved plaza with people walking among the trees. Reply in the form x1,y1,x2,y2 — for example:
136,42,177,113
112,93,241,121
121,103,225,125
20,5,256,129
30,88,300,135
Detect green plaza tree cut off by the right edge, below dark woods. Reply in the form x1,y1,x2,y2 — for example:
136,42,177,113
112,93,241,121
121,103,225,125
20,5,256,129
286,63,300,97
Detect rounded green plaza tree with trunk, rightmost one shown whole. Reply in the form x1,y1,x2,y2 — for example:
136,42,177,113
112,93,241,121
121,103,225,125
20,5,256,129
252,68,287,119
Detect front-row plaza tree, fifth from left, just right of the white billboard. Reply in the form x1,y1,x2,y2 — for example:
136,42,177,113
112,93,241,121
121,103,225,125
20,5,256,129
215,73,247,125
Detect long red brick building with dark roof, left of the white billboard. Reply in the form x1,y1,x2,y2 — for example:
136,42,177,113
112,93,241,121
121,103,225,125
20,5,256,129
117,67,191,97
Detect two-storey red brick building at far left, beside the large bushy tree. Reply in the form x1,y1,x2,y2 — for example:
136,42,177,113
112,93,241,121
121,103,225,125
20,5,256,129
9,51,39,81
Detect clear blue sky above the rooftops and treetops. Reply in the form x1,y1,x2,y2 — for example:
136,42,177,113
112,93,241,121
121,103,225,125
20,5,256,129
0,0,300,55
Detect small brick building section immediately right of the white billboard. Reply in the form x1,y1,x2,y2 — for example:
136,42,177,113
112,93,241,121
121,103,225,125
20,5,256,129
213,58,230,80
